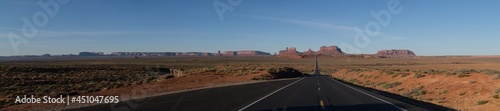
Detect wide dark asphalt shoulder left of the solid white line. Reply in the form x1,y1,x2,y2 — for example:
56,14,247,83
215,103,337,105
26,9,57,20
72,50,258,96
69,78,299,111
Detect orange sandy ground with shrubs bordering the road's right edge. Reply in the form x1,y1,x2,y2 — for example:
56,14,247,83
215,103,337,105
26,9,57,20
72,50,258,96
331,69,500,111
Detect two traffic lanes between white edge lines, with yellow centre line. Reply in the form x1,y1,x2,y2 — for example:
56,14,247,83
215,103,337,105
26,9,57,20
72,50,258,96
240,58,428,111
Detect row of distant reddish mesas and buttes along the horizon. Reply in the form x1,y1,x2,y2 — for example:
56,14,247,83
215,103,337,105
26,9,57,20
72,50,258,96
0,46,416,58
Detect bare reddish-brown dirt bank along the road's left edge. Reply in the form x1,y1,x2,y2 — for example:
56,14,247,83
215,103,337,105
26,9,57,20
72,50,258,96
2,73,265,111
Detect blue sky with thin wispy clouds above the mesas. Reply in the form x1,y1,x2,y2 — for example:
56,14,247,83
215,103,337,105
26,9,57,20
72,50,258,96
0,0,500,56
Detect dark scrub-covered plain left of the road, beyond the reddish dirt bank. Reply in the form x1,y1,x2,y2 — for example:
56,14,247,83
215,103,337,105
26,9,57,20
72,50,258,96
0,57,314,108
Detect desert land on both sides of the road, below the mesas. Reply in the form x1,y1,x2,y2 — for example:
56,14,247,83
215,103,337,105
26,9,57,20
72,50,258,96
0,56,500,111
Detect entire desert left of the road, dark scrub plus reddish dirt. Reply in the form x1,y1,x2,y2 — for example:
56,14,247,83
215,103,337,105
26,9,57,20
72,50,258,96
0,57,313,110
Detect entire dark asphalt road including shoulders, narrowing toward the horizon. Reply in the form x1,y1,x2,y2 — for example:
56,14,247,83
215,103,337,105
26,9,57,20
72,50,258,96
72,58,458,111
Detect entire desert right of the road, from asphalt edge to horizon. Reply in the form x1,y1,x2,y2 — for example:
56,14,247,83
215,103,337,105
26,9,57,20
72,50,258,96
328,57,500,111
